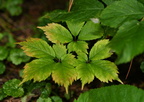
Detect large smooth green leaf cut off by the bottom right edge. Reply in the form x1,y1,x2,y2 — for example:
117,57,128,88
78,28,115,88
74,85,144,102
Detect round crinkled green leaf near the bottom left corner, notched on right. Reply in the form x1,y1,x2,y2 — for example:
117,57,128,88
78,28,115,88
2,79,24,97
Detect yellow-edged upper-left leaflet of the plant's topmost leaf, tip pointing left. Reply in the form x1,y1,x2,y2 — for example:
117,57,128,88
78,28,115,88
38,23,73,43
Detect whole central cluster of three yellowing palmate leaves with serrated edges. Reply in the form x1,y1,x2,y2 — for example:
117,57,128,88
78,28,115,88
19,20,121,92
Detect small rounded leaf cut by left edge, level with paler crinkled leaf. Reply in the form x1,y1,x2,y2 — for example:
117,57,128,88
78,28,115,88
0,46,9,60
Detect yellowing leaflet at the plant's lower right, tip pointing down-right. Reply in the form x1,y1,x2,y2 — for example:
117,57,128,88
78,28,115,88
90,60,121,82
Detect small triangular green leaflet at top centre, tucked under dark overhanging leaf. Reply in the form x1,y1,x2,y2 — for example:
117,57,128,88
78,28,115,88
66,21,84,37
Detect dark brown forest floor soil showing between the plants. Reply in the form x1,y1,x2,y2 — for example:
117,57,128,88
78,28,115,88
0,0,144,102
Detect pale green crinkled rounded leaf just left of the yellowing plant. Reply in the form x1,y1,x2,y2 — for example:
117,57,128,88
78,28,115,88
8,48,30,65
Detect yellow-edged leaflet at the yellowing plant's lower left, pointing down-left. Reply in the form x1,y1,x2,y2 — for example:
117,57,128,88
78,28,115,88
22,58,55,83
